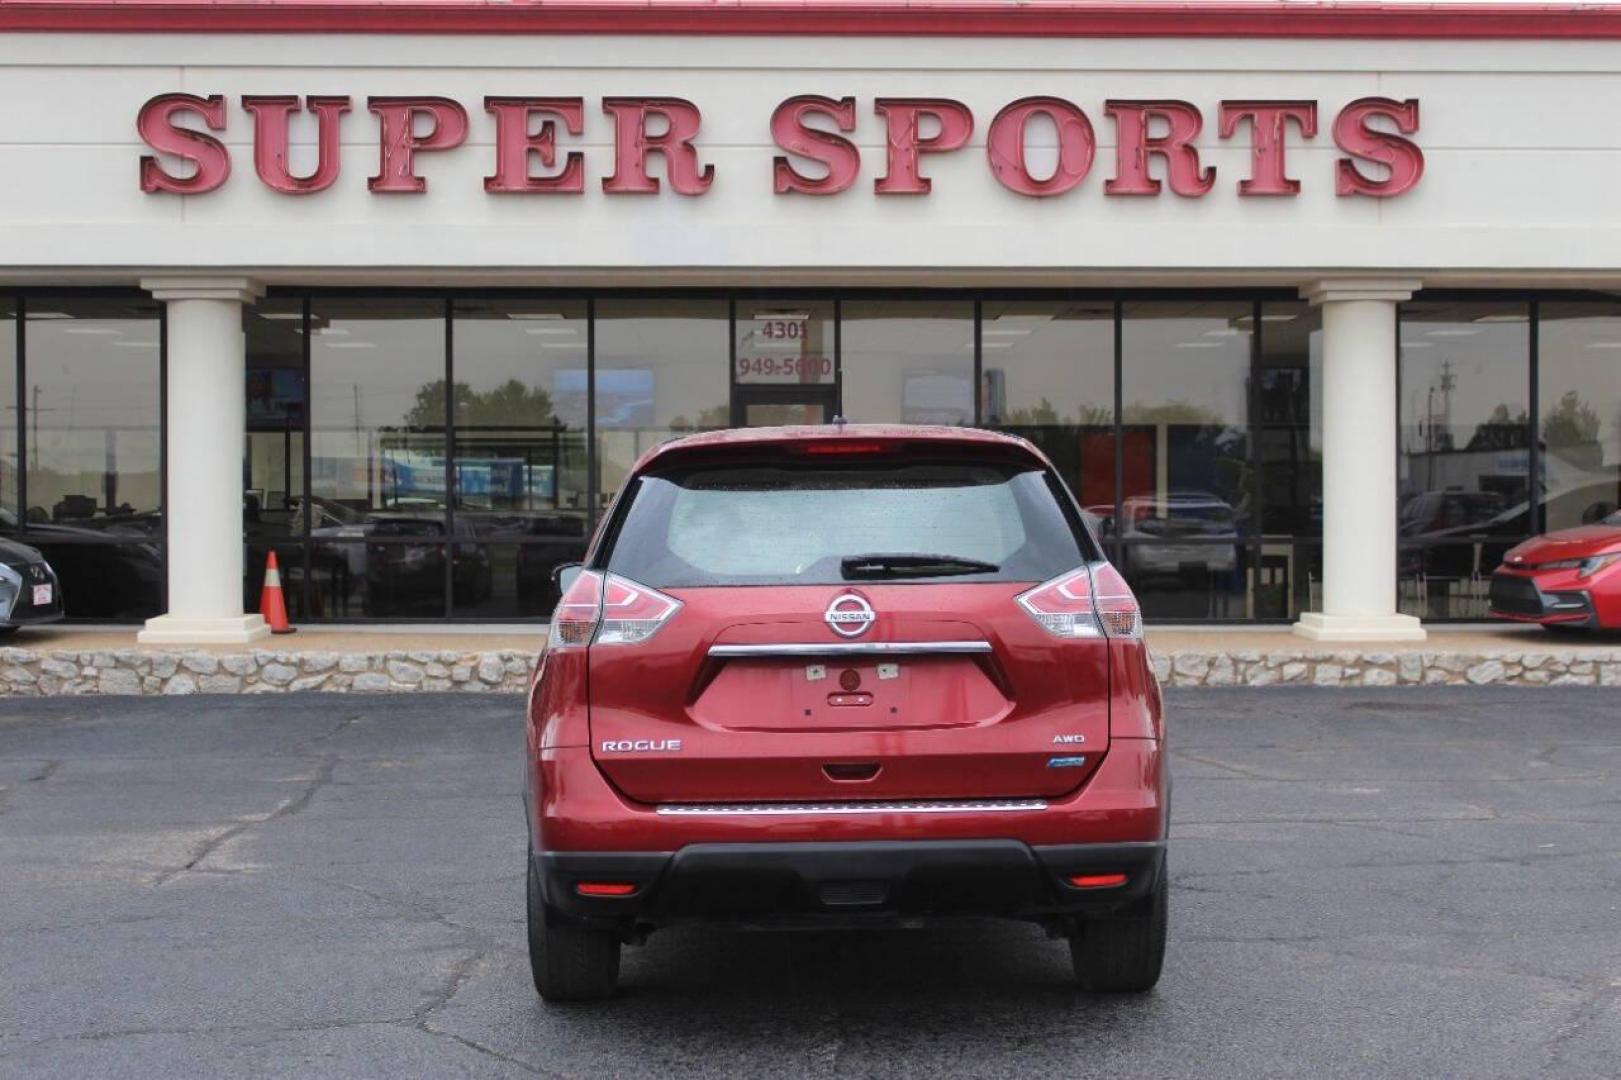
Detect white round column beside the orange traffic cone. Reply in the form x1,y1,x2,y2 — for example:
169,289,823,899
136,277,271,644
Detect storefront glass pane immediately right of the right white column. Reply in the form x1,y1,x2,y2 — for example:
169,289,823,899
1397,300,1532,619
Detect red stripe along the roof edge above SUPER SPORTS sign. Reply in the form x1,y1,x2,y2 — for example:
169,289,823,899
0,0,1621,39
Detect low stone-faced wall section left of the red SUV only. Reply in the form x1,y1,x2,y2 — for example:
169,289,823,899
0,649,535,696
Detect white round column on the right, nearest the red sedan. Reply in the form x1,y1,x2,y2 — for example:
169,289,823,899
1295,279,1425,641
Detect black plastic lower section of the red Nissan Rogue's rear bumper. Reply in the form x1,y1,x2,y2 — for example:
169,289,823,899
530,840,1165,926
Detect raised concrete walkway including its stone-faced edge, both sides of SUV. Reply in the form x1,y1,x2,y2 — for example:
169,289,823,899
0,624,1621,696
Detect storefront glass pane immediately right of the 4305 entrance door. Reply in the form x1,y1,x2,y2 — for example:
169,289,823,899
840,300,974,426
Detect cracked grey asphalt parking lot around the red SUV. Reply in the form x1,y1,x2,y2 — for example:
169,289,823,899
0,689,1621,1078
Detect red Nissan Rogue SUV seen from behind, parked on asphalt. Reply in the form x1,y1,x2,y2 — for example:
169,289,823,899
525,422,1169,1001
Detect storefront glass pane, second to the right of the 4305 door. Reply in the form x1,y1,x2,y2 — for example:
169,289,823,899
979,300,1115,528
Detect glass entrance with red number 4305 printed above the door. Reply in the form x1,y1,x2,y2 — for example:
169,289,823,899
731,300,838,428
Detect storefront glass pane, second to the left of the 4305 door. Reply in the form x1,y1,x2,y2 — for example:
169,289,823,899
451,300,590,618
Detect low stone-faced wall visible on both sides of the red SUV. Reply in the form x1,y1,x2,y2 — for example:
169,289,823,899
0,647,1621,697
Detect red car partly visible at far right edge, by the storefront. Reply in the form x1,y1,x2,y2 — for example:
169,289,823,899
1491,512,1621,629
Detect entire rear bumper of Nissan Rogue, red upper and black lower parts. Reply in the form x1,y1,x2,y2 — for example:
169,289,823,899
527,739,1169,926
